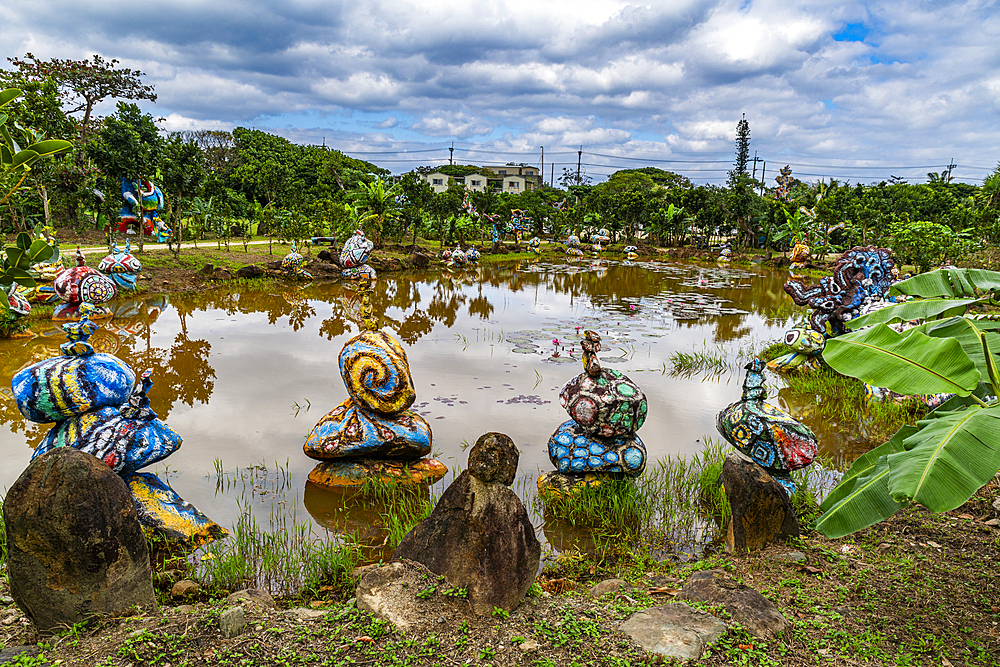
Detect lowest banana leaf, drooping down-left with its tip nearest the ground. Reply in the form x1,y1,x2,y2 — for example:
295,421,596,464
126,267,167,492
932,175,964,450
813,456,903,538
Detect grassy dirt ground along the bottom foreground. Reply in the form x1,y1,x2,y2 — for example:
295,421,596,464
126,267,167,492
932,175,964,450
0,477,1000,667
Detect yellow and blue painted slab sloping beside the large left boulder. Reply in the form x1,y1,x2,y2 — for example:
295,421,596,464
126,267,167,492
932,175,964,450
125,472,229,547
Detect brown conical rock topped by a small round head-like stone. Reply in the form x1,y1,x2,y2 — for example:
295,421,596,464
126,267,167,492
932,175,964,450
394,433,542,616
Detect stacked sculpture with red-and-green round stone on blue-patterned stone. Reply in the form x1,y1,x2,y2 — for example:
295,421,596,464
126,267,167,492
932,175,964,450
538,331,647,497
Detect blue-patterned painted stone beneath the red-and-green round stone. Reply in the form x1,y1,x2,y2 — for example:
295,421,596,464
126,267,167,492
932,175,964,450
548,419,646,476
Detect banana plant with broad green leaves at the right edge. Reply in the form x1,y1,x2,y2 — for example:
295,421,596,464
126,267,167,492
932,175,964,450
815,269,1000,537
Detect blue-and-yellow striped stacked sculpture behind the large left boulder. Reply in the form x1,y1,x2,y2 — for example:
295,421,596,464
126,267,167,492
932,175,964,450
11,317,226,545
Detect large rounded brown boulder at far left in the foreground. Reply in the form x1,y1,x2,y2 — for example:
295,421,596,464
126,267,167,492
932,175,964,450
3,447,156,632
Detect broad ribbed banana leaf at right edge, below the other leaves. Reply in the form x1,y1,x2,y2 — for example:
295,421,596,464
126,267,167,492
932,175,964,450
888,405,1000,512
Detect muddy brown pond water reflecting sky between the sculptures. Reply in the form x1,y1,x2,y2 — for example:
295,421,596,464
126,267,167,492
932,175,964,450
0,261,871,560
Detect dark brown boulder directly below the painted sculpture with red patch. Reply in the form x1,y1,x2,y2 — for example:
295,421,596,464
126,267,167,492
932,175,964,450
722,454,799,552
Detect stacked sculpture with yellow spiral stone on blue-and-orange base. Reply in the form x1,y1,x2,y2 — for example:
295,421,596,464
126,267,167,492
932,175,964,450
303,275,447,488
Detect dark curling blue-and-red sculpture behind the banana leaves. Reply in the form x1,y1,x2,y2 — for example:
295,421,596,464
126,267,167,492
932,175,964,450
785,246,896,336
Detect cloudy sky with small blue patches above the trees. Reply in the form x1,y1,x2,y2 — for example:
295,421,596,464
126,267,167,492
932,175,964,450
0,0,1000,183
